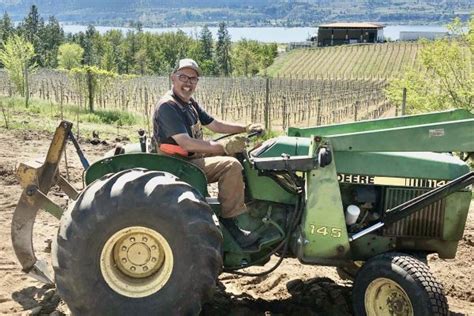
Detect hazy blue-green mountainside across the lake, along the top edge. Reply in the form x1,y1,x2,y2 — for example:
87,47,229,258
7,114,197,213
0,0,474,26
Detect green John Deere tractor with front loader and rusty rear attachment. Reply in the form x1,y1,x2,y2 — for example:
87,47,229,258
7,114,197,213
12,110,474,315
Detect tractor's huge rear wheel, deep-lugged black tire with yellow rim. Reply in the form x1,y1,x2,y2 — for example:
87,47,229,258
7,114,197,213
52,169,222,315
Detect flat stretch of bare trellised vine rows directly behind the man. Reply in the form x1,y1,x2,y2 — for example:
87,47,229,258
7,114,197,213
0,70,393,131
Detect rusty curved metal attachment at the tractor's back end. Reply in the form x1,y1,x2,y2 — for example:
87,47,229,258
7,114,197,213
11,121,78,283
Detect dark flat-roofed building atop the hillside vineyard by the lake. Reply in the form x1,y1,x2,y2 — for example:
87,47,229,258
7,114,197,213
317,23,384,46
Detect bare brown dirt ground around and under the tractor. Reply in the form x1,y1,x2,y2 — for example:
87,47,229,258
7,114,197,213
0,129,474,316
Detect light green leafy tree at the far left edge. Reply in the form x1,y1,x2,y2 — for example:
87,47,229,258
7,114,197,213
0,35,36,107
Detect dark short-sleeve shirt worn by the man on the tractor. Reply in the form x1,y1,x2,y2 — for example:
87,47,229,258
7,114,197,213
153,93,214,145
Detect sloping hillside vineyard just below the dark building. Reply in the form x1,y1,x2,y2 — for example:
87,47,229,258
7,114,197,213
268,42,423,79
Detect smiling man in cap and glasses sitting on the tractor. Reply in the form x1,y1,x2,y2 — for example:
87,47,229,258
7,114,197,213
153,59,263,247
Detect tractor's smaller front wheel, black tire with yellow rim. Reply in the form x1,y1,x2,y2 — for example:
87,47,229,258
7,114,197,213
352,253,448,316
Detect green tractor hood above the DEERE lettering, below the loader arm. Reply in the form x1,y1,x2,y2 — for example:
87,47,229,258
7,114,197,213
251,136,469,180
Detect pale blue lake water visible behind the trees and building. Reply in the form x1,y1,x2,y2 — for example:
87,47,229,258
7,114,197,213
62,24,448,43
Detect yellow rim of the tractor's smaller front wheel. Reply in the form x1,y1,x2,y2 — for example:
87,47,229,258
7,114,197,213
364,278,413,316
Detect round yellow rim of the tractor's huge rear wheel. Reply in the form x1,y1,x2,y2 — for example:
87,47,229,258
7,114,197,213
100,226,173,298
